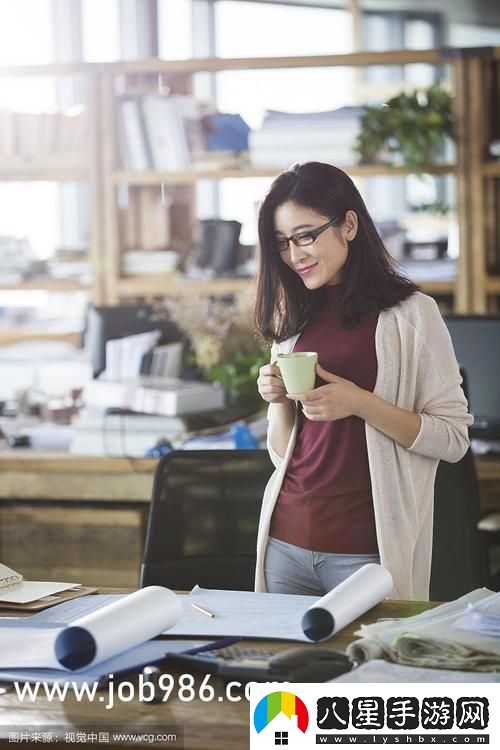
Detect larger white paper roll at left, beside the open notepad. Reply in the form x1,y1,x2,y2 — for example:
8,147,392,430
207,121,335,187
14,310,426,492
55,586,182,670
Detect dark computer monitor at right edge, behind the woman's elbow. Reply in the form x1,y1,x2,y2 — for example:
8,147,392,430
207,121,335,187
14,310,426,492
445,315,500,439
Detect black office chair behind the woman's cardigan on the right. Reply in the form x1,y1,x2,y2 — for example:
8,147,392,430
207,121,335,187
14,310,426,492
430,368,489,601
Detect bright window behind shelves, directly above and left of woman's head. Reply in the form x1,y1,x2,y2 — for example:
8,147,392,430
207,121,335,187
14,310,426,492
215,0,354,244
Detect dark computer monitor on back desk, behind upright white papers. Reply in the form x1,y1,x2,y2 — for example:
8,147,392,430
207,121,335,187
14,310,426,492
84,305,183,377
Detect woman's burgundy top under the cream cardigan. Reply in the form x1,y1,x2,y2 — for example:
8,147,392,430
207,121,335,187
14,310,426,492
269,286,378,554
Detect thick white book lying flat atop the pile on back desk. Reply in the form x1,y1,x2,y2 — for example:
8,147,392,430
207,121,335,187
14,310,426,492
83,377,225,417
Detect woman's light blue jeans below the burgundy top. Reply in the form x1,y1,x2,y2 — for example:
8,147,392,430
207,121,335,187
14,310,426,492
264,537,380,596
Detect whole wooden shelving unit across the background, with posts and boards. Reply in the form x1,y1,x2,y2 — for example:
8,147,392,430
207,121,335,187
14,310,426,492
0,48,500,322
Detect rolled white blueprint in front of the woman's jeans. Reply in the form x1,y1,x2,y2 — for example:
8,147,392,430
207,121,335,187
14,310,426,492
302,563,393,641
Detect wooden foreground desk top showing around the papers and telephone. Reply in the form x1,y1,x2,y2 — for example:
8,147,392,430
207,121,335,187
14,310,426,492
0,602,434,750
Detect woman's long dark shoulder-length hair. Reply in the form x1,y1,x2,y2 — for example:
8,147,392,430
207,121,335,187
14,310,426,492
254,161,418,341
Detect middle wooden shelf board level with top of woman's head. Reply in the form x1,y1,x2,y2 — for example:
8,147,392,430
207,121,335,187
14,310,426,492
113,164,455,186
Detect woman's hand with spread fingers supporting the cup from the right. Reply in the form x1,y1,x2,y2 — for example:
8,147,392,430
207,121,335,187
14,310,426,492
287,365,363,422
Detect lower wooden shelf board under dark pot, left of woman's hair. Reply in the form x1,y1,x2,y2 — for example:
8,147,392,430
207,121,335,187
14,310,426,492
118,275,252,298
